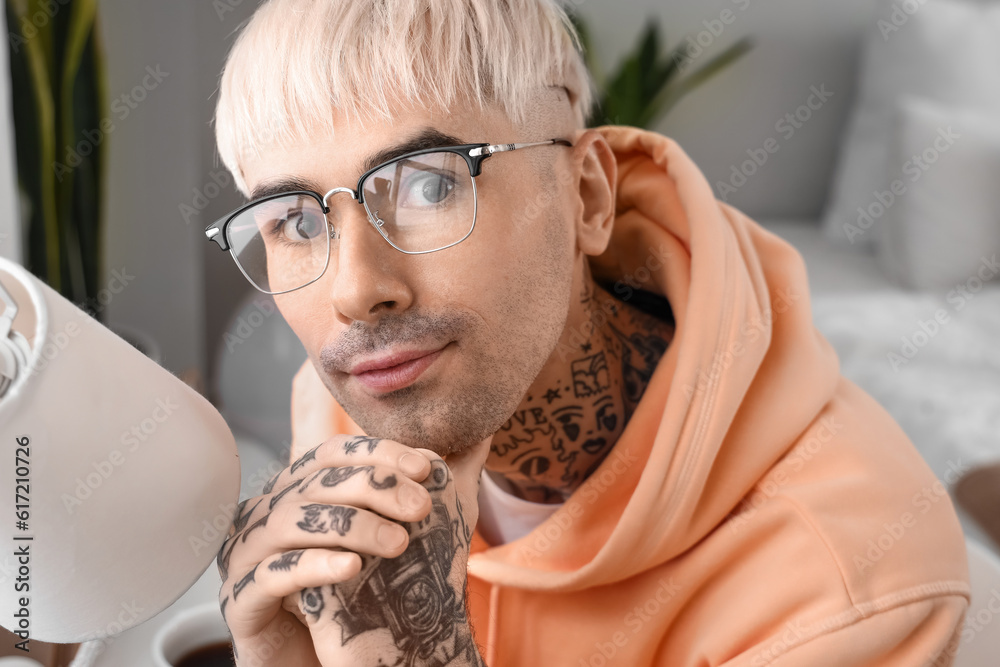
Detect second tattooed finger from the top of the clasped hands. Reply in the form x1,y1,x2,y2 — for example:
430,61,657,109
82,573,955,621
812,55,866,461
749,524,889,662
290,466,431,521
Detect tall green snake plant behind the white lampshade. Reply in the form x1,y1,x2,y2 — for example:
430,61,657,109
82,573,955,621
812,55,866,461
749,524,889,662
6,0,109,319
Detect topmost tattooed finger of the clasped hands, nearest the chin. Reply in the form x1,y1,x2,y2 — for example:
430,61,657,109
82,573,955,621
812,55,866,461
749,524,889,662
263,435,430,494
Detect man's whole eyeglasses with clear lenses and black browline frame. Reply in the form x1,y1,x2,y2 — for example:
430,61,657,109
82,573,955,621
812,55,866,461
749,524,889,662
205,139,572,294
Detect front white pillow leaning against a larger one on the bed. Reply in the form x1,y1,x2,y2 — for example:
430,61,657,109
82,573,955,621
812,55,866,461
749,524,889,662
878,97,1000,293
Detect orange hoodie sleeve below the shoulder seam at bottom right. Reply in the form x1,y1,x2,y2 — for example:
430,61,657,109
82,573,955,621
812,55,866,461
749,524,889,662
726,595,975,667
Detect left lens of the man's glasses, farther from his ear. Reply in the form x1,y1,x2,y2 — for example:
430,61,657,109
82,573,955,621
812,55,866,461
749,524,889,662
227,194,330,294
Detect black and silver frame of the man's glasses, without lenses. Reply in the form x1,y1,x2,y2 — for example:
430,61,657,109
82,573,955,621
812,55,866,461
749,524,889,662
205,139,573,294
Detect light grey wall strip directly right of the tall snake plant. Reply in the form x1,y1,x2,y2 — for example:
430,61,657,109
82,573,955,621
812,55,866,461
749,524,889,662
98,0,207,373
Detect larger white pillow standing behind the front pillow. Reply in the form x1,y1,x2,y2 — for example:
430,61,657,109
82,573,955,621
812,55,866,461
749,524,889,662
823,0,1000,246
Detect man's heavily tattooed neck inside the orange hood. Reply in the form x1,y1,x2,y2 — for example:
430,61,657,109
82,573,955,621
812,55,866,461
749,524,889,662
487,261,673,502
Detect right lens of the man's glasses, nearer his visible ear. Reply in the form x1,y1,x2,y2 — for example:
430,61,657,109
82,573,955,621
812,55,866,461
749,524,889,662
363,153,476,252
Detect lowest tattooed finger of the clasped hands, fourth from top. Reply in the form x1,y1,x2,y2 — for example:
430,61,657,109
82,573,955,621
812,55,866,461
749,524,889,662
226,549,361,632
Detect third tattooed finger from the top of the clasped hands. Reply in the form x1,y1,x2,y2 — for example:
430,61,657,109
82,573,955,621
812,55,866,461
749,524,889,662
228,503,409,574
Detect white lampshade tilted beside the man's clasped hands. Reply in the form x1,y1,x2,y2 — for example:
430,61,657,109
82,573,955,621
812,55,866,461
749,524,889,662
0,257,240,644
